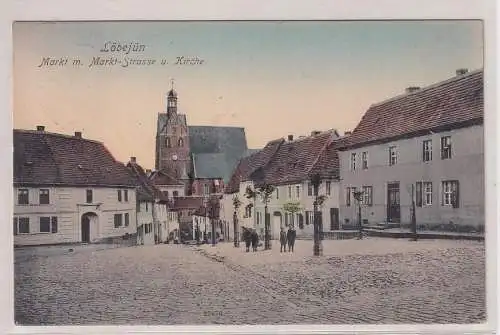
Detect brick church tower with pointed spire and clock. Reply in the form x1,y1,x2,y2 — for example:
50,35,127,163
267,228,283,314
155,82,191,181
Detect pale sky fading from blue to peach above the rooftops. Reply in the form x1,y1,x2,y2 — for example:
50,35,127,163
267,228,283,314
13,21,483,168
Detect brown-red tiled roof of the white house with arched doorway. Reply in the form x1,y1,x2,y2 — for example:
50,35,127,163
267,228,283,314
14,129,137,188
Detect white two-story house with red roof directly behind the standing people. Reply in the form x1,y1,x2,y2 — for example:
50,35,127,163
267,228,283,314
251,130,339,239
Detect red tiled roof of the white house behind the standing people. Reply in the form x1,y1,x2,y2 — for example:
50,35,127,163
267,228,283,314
259,130,338,185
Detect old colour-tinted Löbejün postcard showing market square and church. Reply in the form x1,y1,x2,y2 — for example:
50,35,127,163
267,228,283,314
11,20,490,335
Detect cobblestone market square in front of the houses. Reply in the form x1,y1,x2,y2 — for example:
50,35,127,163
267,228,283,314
15,239,486,325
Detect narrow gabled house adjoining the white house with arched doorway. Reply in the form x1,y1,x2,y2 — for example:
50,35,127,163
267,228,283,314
127,157,179,245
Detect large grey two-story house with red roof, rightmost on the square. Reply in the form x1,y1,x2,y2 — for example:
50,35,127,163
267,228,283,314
339,70,485,231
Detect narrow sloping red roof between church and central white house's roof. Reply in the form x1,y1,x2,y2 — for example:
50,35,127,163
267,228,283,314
225,138,285,193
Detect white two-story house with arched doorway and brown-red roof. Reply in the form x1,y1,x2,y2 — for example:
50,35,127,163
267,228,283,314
13,126,136,245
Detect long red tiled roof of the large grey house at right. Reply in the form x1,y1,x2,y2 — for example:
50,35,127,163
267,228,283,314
342,69,484,149
